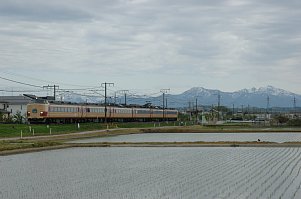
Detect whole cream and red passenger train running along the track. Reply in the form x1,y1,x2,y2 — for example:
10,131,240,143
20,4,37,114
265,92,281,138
27,103,178,123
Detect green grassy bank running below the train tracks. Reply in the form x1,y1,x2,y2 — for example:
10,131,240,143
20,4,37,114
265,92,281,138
0,122,301,138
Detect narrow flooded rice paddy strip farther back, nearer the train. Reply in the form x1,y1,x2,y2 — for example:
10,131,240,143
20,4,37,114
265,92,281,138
68,132,301,143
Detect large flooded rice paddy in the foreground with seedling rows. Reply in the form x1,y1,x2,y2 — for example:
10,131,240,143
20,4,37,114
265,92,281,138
0,147,301,199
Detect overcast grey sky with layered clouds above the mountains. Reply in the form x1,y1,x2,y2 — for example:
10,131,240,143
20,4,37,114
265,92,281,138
0,0,301,94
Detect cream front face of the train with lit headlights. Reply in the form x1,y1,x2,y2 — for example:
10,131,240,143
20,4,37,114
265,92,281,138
27,103,49,123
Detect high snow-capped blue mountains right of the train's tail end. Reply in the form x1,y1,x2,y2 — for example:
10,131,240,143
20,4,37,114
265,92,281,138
173,86,301,107
